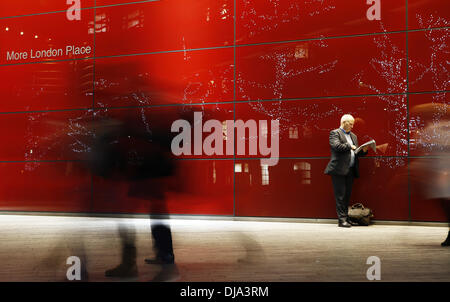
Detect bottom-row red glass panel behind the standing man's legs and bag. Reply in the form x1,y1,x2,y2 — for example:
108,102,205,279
236,158,408,220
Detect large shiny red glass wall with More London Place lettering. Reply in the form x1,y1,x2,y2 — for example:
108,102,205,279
0,0,450,221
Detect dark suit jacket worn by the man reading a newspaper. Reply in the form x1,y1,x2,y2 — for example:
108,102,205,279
324,128,367,178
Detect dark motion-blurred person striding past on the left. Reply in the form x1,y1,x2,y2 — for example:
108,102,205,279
88,113,178,281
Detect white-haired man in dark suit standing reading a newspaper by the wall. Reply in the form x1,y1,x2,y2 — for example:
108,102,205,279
324,114,367,228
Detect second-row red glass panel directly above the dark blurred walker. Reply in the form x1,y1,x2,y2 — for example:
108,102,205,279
95,49,233,107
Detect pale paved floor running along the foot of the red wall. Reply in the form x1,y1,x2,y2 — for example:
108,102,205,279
0,215,450,282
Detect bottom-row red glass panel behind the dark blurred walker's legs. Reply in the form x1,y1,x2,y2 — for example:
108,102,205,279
93,160,233,215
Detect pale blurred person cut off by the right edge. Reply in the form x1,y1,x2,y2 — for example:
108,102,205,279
410,103,450,246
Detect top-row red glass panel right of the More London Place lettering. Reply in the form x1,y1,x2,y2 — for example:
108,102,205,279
96,0,234,56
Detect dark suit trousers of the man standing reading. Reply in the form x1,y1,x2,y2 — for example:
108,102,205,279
331,168,354,220
